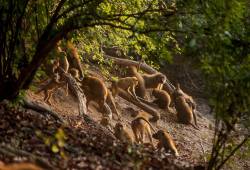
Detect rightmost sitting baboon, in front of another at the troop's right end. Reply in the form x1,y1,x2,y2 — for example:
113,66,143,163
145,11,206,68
175,96,198,129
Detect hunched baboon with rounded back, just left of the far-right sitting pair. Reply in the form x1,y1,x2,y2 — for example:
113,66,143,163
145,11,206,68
152,89,172,112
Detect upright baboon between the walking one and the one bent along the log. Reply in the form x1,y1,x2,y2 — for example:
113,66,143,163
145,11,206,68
129,66,146,99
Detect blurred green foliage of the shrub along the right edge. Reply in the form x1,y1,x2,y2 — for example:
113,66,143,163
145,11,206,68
182,0,250,169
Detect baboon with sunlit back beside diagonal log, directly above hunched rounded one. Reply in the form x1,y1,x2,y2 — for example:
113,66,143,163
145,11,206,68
142,73,167,89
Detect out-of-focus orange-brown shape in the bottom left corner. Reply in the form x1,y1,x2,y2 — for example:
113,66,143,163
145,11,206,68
0,163,42,170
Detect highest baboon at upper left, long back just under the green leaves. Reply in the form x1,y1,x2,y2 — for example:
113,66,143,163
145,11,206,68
65,40,84,77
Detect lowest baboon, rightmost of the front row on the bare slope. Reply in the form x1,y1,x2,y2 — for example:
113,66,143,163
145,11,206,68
153,130,179,156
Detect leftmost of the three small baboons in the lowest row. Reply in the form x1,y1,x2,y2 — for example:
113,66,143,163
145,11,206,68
114,122,134,144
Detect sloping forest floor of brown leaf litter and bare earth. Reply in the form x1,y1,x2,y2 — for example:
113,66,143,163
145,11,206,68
0,58,247,169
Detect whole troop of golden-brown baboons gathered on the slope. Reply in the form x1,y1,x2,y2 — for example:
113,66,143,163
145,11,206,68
37,41,201,156
